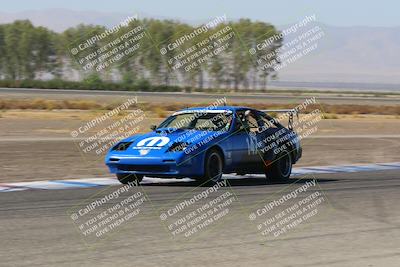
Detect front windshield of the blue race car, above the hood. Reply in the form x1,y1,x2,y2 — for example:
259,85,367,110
158,112,232,131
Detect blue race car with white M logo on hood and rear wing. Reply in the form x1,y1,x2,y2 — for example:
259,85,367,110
105,106,302,184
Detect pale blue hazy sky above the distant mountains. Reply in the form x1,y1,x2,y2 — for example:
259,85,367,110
0,0,400,26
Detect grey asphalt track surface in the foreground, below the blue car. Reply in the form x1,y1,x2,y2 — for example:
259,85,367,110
0,170,400,266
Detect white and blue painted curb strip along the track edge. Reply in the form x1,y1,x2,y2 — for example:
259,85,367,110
0,162,400,192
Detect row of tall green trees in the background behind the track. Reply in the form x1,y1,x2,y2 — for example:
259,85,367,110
0,19,282,90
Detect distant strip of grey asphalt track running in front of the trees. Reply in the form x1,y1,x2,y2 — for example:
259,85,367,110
0,88,400,105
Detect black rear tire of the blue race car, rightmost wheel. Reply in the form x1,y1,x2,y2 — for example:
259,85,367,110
265,150,293,182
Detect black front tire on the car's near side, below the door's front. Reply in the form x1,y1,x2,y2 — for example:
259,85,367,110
202,149,224,183
